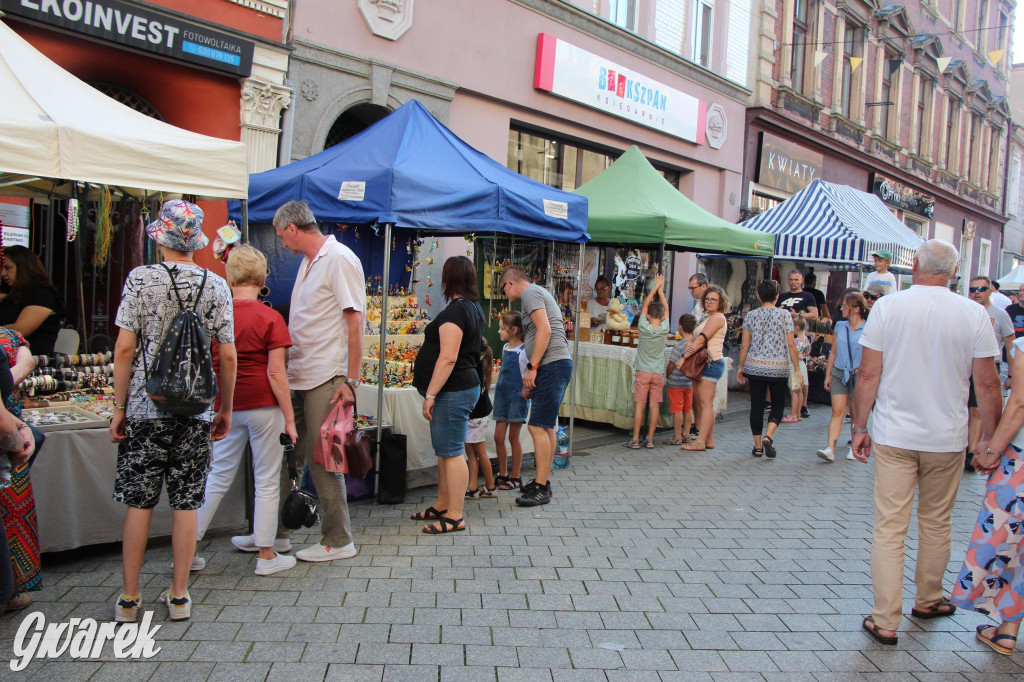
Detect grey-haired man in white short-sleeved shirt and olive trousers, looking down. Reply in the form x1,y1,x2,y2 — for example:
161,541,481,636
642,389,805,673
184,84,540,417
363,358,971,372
273,202,367,561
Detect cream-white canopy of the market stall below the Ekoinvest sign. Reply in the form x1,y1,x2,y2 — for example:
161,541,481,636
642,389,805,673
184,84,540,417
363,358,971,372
0,17,249,199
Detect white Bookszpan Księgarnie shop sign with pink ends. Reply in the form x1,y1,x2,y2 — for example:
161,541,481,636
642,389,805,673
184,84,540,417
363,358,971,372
534,33,707,144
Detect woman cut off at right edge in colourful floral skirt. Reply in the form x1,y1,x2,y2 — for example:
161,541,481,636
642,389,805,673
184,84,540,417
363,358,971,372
950,338,1024,655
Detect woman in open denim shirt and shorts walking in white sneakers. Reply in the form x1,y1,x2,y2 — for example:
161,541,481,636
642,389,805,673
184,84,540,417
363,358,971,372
817,292,867,462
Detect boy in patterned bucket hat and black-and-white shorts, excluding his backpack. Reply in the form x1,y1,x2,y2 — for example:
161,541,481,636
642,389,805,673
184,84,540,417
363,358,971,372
110,199,237,623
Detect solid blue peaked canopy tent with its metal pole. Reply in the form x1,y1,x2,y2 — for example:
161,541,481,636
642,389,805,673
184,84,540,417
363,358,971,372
228,99,590,473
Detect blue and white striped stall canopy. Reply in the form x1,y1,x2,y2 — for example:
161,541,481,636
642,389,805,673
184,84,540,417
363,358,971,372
740,180,923,268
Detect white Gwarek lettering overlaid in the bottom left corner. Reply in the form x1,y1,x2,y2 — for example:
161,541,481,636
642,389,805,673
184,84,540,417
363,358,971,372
10,611,162,673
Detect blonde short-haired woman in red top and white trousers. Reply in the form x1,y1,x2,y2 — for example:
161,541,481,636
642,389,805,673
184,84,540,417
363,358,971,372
191,245,297,576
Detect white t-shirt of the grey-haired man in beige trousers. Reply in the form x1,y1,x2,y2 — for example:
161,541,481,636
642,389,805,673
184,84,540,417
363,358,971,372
860,285,999,453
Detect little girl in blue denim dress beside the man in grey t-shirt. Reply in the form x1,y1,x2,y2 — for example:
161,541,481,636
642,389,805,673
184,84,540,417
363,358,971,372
492,312,529,491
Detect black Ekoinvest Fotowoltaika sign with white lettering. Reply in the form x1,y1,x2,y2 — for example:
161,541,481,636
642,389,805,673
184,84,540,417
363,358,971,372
0,0,255,76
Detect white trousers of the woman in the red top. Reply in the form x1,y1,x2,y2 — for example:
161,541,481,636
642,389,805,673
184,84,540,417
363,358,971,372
198,407,285,547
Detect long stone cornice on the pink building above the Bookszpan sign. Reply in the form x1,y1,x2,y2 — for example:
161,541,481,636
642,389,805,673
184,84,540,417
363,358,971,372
509,0,753,104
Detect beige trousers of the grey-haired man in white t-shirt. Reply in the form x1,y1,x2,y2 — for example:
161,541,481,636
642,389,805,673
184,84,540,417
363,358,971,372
871,444,964,630
